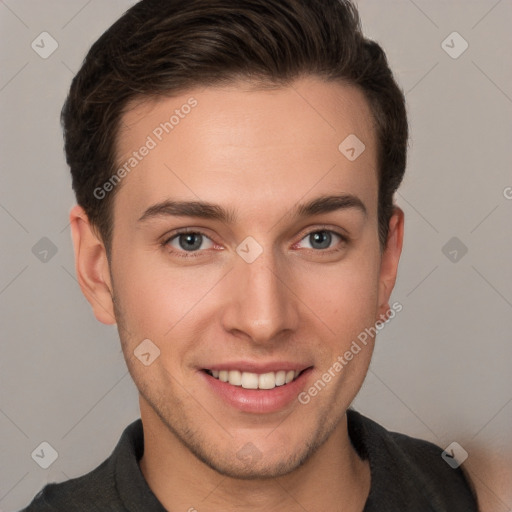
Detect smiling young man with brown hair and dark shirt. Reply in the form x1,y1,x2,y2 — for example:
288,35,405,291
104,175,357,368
22,0,477,512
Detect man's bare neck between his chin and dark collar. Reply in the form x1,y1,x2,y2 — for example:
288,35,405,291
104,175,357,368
139,404,370,512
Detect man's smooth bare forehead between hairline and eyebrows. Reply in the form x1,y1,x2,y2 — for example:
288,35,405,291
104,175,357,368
115,78,377,222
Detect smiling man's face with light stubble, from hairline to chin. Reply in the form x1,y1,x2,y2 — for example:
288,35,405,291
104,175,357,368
78,78,398,478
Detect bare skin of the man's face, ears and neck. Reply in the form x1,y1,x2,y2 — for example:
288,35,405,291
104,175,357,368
70,77,404,512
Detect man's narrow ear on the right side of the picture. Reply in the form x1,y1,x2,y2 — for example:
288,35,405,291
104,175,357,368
378,206,404,320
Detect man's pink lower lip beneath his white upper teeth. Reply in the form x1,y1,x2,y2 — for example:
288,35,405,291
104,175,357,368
200,368,313,414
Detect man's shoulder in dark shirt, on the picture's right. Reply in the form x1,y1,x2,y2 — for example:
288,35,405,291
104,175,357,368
347,409,478,512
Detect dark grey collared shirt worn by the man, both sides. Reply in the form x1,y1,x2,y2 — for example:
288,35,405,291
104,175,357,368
22,409,478,512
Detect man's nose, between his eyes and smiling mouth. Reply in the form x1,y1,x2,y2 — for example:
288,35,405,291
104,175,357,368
222,247,299,345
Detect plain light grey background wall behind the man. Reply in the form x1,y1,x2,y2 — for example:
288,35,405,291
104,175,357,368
0,0,512,512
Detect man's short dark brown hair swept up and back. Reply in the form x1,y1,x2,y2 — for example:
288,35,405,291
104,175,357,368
62,0,408,254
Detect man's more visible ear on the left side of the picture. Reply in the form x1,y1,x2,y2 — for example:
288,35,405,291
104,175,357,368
69,205,116,325
